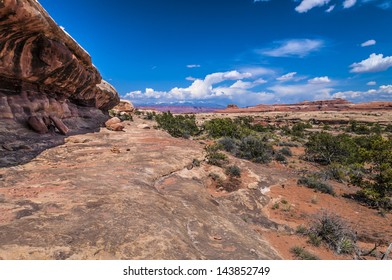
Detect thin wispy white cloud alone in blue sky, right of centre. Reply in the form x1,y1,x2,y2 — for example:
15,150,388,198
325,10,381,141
262,39,324,57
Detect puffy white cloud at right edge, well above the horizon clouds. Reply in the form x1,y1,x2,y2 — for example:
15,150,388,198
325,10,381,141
350,53,392,73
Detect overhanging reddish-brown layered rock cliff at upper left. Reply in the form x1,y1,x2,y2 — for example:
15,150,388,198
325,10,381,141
0,0,119,128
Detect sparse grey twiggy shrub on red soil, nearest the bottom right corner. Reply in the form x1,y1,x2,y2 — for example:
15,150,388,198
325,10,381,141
309,212,356,254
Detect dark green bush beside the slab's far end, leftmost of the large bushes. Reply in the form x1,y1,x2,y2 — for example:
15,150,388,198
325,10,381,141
155,112,200,138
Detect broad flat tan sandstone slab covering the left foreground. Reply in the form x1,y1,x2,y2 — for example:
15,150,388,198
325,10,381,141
0,119,284,259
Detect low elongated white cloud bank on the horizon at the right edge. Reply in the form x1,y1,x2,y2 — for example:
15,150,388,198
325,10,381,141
333,85,392,101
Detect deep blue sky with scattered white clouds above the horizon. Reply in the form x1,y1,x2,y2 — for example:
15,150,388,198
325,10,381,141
39,0,392,106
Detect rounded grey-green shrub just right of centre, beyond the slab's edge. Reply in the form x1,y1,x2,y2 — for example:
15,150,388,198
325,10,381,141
237,136,273,163
